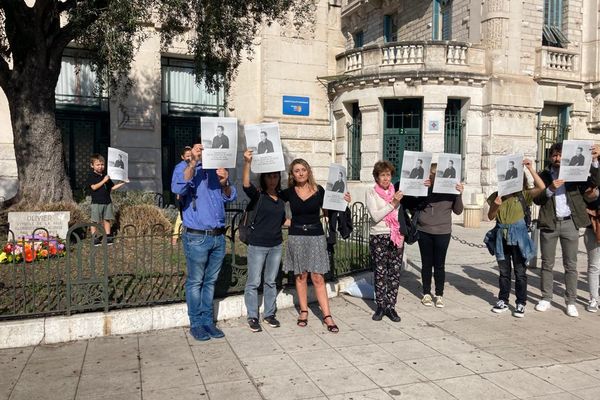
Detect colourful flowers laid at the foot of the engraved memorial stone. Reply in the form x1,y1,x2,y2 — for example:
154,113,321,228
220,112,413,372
0,235,66,264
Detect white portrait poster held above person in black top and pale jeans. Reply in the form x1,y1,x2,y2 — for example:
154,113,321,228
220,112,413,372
244,122,285,174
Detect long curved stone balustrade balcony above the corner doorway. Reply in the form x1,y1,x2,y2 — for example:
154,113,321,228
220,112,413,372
336,41,485,81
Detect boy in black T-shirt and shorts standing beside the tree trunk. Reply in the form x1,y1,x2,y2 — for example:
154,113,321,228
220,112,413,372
86,154,127,245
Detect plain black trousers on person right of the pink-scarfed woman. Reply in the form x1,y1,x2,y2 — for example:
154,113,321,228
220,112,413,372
419,231,450,296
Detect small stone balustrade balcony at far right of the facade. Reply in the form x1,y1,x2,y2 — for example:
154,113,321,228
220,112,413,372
535,47,581,81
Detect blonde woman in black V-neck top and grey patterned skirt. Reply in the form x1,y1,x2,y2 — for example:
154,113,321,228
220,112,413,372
281,159,351,333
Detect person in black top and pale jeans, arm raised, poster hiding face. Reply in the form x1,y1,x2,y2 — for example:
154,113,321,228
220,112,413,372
242,149,285,332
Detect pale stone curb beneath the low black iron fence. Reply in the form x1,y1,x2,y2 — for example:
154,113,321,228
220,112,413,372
0,272,370,349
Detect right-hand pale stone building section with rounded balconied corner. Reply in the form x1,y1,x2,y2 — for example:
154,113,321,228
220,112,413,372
329,0,600,204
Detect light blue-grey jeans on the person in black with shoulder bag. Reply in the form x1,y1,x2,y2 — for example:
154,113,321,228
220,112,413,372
244,245,282,318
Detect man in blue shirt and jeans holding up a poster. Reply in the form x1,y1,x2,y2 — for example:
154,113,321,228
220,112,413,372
171,143,237,340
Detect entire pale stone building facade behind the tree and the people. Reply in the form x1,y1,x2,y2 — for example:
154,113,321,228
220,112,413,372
0,0,600,209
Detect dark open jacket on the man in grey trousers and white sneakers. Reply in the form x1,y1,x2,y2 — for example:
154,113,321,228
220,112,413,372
533,166,600,230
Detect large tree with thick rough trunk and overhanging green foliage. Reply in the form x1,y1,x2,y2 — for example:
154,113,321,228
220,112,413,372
0,0,315,203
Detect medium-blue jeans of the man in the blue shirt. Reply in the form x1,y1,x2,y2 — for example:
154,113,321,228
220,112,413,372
182,232,225,328
